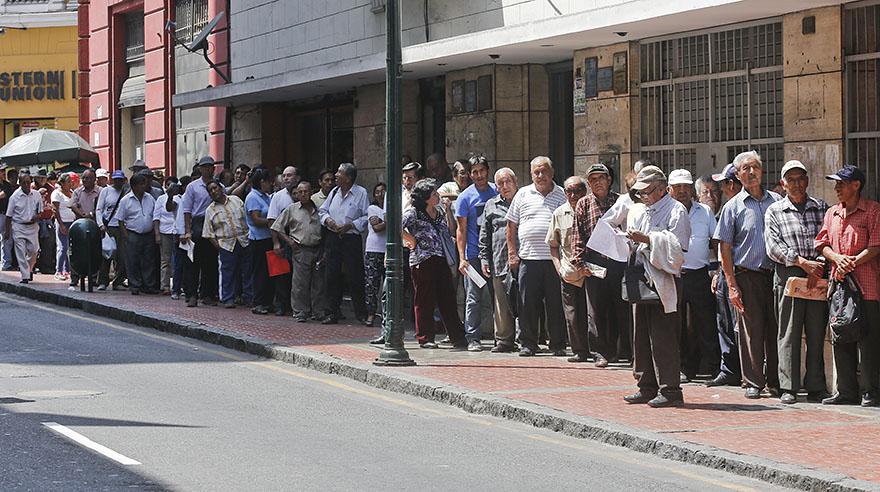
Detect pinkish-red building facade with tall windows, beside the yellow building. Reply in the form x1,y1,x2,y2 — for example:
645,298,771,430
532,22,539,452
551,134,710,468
79,0,229,175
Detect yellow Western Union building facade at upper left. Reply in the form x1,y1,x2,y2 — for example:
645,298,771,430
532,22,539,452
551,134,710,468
0,0,79,146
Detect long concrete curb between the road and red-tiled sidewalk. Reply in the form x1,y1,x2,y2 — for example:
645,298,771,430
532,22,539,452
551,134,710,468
0,281,880,492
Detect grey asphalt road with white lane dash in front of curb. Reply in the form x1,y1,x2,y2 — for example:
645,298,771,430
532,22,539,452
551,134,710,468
0,294,773,492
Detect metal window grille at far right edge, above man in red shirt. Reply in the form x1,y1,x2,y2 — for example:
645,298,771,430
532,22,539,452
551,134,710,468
843,1,880,197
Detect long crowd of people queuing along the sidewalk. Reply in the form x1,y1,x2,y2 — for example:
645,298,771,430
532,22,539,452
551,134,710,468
0,151,880,407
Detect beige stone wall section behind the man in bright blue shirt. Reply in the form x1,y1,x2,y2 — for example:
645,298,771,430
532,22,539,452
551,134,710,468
446,65,550,182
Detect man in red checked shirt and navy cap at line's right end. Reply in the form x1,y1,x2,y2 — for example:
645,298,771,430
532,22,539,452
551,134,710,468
816,166,880,407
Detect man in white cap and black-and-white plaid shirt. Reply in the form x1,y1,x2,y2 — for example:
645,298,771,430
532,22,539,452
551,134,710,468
764,161,828,404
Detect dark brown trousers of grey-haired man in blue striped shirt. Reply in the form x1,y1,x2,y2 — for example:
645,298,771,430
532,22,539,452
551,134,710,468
736,270,779,388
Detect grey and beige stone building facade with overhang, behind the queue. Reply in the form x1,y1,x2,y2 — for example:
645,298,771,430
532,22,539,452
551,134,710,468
173,0,880,204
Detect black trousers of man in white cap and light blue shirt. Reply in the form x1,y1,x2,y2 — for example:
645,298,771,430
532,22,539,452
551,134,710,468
678,267,721,378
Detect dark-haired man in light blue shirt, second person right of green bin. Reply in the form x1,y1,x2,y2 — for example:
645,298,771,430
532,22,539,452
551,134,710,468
117,174,159,296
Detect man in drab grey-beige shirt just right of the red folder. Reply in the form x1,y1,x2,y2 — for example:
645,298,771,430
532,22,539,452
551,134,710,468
272,181,326,323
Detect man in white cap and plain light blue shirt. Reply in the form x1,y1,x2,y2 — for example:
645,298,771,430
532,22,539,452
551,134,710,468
669,169,721,383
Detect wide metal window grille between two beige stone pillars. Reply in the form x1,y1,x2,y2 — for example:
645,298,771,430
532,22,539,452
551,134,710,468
640,20,783,183
